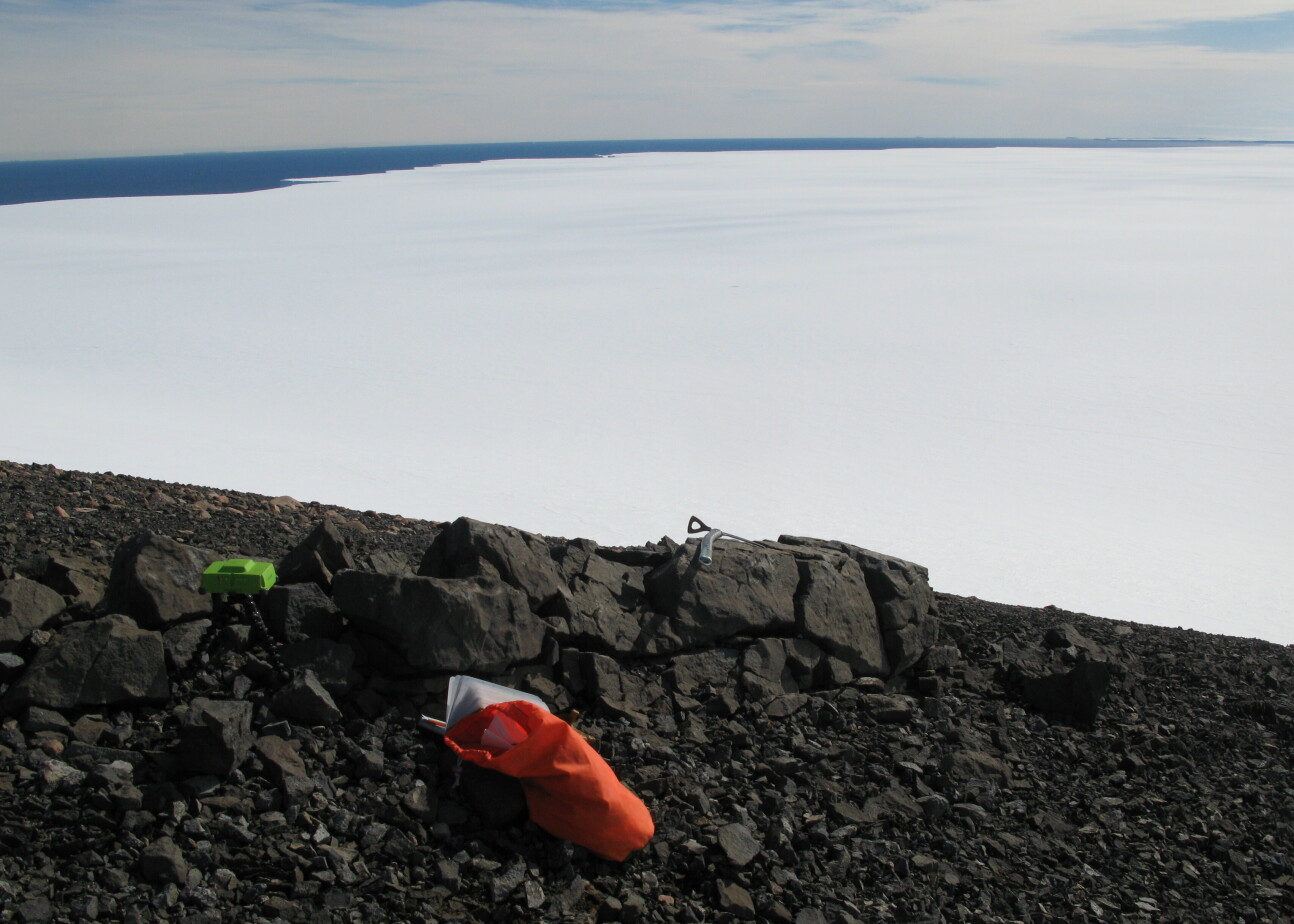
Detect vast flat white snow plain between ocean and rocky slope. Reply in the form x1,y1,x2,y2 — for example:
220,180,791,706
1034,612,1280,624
0,146,1294,643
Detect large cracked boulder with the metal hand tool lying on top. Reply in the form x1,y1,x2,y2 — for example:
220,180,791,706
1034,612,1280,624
644,542,800,654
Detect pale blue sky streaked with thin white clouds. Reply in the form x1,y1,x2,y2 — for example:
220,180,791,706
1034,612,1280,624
0,0,1294,160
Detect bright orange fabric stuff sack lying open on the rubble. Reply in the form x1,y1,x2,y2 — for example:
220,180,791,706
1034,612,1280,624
445,701,656,861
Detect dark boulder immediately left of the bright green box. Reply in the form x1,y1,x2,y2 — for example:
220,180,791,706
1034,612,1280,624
104,533,220,629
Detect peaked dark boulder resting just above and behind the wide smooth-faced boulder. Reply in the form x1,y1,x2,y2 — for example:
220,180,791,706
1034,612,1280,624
418,516,571,615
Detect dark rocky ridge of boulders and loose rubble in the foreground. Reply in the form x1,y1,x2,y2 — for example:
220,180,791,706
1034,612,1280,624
0,462,1294,924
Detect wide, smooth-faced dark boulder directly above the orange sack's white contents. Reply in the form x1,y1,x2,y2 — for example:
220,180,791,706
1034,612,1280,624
333,571,546,674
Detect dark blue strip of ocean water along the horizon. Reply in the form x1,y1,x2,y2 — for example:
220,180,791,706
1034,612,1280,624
0,138,1268,206
